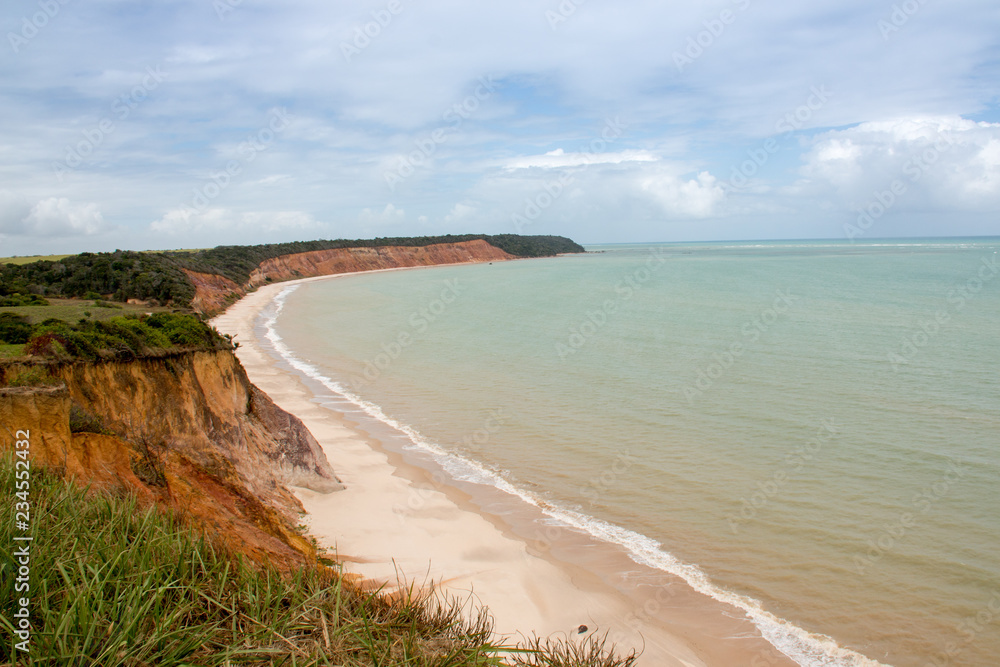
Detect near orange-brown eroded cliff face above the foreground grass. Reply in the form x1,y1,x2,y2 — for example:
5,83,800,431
0,350,343,565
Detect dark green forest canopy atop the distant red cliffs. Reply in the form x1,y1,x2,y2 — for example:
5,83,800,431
0,234,584,306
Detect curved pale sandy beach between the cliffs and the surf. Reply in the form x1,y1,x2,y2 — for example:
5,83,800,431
212,269,795,666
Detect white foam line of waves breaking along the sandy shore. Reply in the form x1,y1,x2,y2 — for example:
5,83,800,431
262,285,884,667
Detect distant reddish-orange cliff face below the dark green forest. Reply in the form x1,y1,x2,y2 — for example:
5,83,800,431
184,240,514,314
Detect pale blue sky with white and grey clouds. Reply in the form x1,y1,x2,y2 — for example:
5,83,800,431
0,0,1000,256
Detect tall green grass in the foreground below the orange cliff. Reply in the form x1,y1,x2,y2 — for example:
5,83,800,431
0,456,634,667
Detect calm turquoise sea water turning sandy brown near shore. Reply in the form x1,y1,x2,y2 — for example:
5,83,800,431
273,239,1000,667
